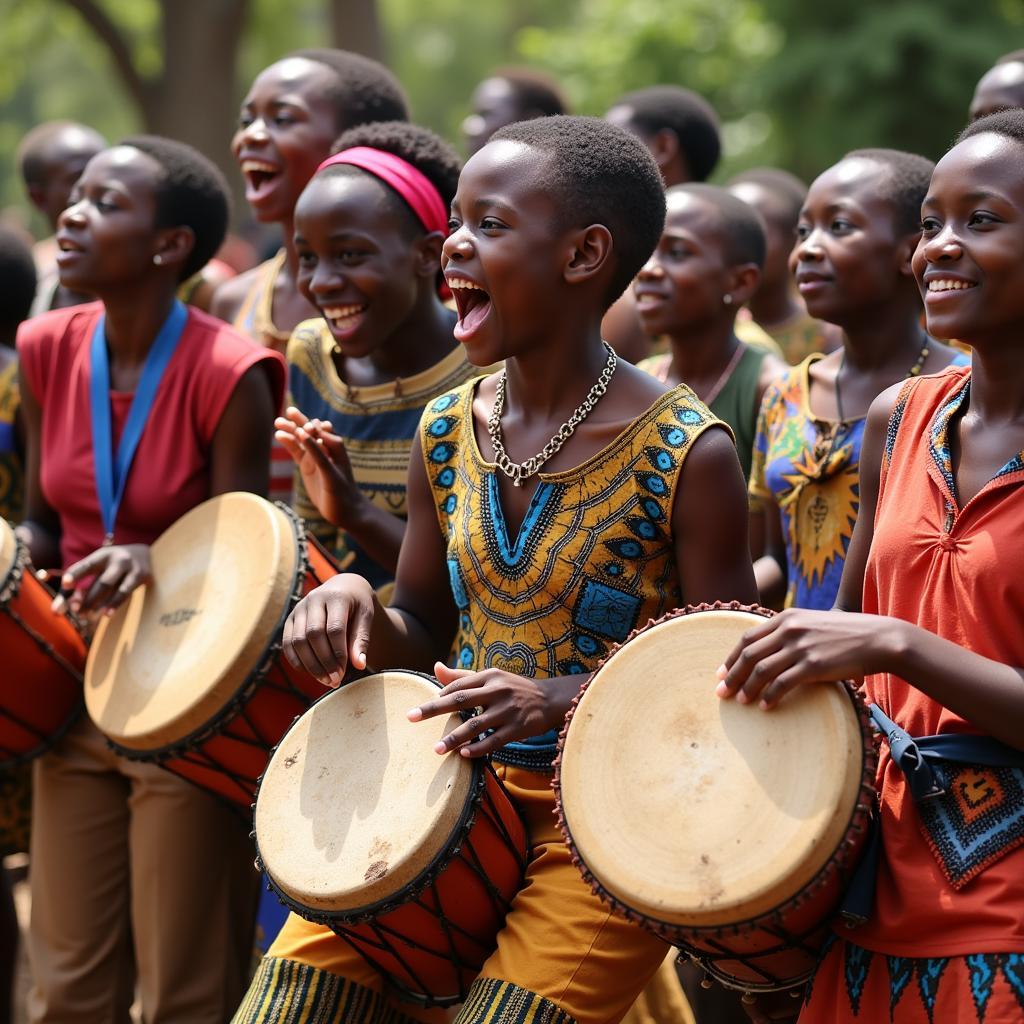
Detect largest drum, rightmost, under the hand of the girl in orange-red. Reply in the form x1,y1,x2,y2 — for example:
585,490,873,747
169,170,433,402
554,603,877,991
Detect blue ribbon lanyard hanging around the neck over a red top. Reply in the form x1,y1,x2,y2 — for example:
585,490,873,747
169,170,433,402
89,299,188,544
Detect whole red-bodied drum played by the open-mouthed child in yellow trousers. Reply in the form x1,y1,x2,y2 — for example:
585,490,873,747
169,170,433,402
255,672,527,1006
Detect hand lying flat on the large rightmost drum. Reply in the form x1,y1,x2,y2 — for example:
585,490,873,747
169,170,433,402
716,608,898,711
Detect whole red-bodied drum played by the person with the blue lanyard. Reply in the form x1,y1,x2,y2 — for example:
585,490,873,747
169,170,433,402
85,493,338,807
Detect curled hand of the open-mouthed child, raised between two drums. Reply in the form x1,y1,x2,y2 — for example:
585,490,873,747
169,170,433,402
282,572,377,686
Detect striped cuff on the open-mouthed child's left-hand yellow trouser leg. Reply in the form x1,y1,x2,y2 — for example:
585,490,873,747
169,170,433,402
231,956,419,1024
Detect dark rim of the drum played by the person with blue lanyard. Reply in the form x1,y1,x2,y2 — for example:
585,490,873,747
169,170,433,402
97,495,323,761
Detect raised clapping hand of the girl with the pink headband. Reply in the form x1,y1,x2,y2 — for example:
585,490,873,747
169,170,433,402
273,406,366,526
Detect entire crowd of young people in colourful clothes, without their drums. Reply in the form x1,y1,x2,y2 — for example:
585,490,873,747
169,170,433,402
0,39,1024,1024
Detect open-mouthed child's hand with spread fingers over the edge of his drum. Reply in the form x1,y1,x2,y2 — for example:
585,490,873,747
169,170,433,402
409,662,580,758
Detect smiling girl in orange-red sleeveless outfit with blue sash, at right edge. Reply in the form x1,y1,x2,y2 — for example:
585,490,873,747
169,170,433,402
720,110,1024,1024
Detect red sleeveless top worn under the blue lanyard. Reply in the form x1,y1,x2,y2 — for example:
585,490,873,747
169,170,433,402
17,302,287,566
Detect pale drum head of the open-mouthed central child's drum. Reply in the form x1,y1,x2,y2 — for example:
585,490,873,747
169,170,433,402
256,672,479,915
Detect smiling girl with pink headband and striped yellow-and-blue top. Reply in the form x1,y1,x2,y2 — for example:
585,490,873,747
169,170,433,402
278,122,479,588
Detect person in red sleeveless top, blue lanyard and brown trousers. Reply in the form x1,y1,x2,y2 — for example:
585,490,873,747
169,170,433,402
17,137,285,1024
